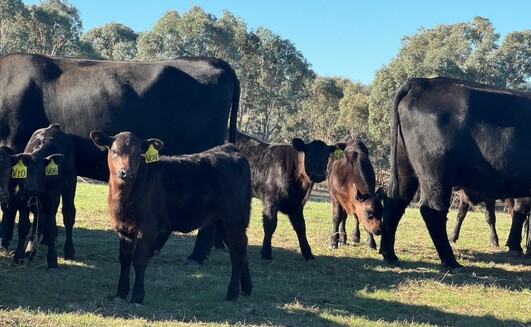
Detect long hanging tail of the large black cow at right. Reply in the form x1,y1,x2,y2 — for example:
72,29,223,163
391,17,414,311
388,79,413,199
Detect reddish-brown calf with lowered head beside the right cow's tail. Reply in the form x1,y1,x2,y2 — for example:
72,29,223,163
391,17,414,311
328,136,384,249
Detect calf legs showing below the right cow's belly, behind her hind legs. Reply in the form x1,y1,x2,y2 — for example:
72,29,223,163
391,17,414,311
450,188,499,247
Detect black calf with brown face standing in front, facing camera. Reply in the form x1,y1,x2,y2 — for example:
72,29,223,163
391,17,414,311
90,131,252,304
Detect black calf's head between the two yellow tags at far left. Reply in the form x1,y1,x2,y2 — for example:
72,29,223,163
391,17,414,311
12,153,65,196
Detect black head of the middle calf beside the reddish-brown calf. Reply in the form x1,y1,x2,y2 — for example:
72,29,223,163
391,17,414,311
291,138,346,183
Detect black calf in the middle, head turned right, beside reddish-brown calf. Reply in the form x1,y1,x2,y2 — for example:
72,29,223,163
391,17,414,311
236,132,345,260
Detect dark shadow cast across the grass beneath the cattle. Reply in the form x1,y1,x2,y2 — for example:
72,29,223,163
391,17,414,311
0,228,531,326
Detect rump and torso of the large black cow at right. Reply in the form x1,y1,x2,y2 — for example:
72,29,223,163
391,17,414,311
395,78,531,198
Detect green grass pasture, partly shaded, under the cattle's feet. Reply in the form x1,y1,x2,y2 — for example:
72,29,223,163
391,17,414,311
0,183,531,327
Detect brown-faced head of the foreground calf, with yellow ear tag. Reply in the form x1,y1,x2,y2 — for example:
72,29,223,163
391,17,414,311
90,131,164,185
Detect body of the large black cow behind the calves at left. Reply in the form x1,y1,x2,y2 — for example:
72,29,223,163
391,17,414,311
0,54,240,181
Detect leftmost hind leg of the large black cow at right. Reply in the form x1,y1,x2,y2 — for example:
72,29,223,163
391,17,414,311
380,149,419,265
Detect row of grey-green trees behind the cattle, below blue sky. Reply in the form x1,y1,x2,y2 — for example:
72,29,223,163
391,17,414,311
0,0,531,167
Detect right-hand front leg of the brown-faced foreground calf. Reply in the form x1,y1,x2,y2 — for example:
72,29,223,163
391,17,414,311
131,230,159,304
